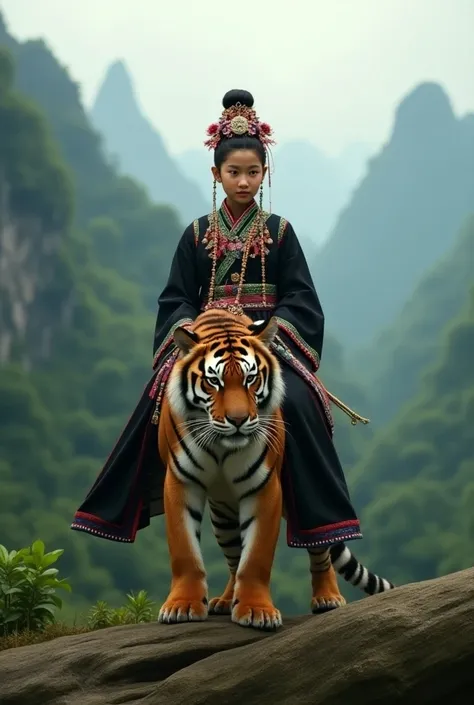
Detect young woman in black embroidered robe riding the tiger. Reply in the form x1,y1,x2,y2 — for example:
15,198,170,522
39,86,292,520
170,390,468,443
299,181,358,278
72,91,362,550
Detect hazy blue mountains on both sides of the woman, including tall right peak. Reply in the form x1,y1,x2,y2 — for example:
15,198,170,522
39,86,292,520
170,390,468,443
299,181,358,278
91,61,474,349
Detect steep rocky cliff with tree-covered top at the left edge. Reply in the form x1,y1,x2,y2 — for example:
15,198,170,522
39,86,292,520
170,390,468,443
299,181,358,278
0,50,72,364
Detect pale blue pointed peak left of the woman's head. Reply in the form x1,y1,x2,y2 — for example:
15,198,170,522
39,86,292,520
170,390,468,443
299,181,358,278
91,61,211,224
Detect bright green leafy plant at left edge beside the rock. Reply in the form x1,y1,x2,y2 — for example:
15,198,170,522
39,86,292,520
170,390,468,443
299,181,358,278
0,541,71,636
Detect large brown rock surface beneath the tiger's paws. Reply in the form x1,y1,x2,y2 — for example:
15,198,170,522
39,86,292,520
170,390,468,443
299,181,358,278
0,569,474,705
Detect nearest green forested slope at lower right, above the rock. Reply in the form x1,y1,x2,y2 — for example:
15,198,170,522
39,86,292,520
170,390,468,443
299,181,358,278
351,279,474,583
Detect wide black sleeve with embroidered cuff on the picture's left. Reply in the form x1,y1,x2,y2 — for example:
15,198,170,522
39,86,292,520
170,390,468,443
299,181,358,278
153,224,199,368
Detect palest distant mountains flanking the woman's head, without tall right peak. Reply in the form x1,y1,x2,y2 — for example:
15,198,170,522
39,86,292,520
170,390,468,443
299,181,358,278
90,61,370,253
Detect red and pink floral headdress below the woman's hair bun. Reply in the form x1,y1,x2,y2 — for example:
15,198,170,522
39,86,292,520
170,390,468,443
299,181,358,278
204,103,275,149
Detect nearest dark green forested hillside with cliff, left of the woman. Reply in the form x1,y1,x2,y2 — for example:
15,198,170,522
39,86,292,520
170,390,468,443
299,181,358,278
0,44,154,612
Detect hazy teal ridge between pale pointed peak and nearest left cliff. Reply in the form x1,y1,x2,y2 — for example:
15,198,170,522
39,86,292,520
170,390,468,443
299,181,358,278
0,21,183,313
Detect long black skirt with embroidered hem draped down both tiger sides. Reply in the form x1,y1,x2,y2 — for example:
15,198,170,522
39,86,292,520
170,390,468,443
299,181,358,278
71,350,362,548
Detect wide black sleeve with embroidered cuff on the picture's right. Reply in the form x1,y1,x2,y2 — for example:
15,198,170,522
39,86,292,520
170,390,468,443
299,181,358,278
275,223,324,370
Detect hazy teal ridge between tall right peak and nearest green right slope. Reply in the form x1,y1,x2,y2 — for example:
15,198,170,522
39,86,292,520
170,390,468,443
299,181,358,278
360,213,474,426
